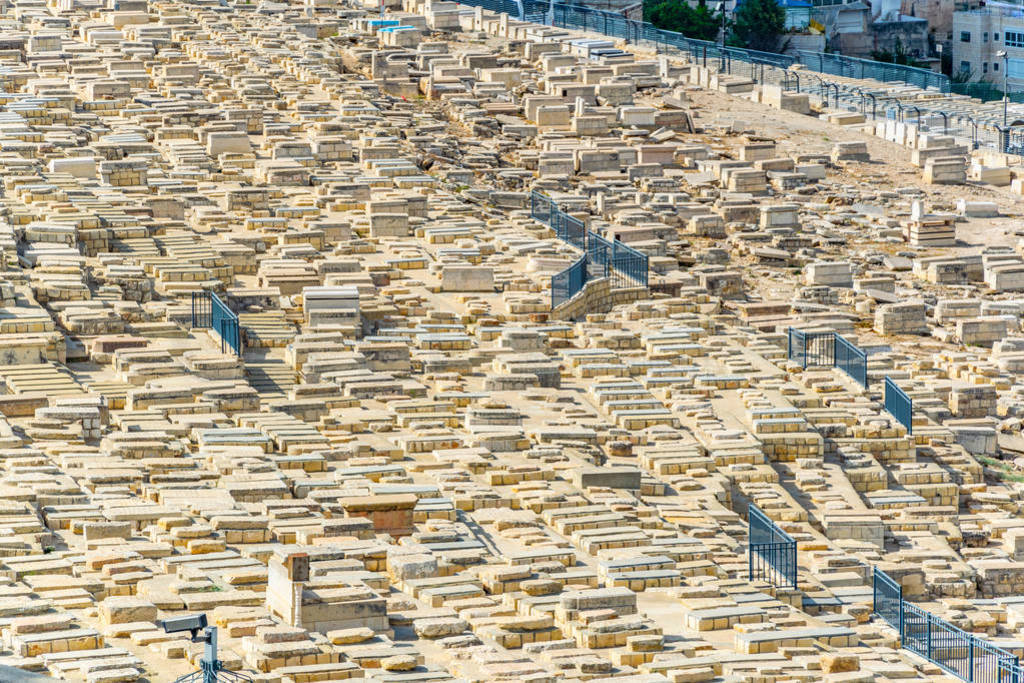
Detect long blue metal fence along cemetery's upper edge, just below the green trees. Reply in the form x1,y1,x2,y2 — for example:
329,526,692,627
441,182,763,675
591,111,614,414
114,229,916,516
489,0,950,93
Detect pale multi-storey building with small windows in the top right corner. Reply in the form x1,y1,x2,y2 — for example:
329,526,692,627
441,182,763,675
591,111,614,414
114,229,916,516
952,3,1024,87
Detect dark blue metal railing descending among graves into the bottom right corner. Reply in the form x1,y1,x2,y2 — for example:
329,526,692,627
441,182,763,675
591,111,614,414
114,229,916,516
872,568,1024,683
